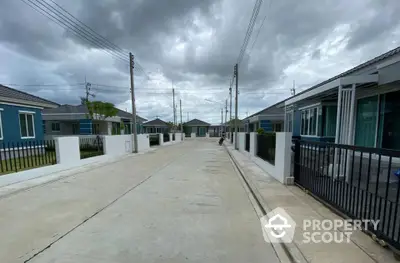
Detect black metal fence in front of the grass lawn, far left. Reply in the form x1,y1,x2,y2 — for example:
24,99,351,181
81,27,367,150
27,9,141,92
0,140,57,175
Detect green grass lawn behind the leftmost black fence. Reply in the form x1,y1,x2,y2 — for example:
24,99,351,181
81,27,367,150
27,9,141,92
0,152,57,175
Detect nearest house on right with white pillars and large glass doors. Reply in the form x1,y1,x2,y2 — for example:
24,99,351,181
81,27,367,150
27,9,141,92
284,47,400,150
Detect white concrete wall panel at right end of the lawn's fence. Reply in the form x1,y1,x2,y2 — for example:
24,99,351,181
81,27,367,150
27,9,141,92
55,136,81,164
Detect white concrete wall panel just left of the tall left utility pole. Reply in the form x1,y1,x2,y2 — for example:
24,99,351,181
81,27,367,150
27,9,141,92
103,135,133,156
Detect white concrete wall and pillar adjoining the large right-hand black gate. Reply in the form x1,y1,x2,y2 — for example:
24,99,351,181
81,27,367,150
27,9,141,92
250,132,293,184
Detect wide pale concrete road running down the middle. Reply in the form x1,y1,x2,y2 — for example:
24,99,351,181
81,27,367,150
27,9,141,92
0,139,279,263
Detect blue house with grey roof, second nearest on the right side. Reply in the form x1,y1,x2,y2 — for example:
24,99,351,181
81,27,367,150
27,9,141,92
243,102,285,132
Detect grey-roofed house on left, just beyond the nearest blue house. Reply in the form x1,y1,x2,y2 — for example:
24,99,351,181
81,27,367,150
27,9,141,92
42,104,146,138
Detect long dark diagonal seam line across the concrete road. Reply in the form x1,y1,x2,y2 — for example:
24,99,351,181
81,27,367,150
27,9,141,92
24,154,184,263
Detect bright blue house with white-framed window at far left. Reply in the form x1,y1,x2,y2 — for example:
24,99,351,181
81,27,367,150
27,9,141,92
0,85,59,145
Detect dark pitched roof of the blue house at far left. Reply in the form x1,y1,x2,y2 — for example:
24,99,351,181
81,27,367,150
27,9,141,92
0,84,60,108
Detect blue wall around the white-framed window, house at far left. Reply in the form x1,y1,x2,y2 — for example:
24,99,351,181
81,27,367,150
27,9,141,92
0,103,44,144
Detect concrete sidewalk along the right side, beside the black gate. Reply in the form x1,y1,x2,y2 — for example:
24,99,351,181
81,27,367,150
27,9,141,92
226,143,398,263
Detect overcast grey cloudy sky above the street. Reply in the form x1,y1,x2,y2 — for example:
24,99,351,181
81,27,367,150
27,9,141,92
0,0,400,123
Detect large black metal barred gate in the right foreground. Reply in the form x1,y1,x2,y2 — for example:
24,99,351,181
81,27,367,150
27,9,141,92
294,140,400,249
